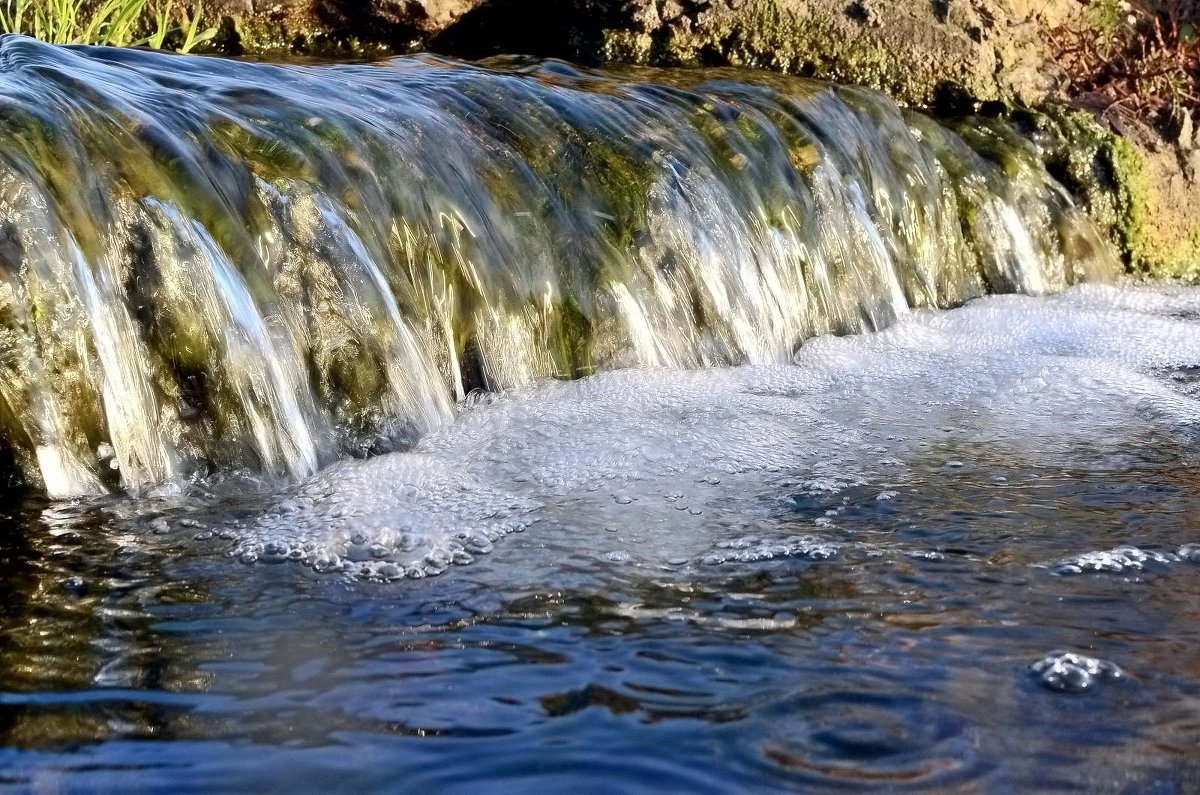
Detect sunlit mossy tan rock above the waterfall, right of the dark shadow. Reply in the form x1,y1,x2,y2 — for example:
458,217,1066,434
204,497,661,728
580,0,1055,106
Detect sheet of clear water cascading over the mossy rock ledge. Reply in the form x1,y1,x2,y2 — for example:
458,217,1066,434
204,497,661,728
0,37,1117,496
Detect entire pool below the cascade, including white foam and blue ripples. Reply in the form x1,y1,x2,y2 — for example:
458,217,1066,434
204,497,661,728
0,287,1200,793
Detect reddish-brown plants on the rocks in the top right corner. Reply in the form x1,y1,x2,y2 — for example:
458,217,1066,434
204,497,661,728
1049,0,1200,135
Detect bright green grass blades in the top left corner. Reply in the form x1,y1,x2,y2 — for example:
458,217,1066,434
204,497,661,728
0,0,217,53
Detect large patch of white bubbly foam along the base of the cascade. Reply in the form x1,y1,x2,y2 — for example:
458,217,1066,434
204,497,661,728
235,287,1200,578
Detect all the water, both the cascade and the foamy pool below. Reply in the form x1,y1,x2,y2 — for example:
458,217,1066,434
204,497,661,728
0,37,1200,793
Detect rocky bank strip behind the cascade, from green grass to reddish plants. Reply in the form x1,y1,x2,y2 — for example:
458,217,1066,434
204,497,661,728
210,0,1057,112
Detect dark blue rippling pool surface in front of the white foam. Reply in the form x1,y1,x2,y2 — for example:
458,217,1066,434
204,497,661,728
0,462,1200,791
